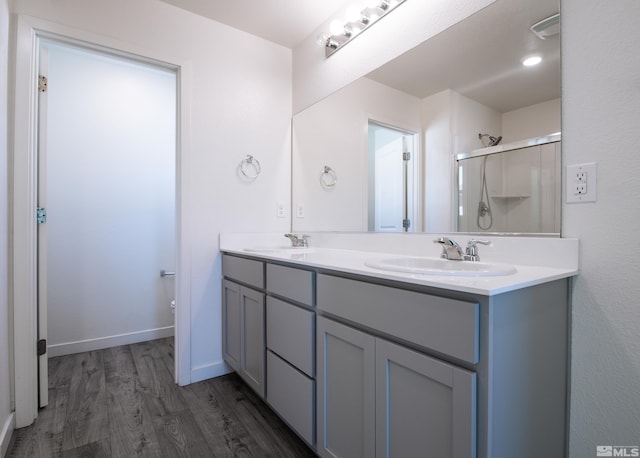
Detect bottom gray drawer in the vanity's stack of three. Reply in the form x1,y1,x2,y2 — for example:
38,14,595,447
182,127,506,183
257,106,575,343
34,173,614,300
267,350,316,446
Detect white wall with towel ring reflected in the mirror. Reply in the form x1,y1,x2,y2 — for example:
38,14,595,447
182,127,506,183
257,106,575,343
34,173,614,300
292,78,420,232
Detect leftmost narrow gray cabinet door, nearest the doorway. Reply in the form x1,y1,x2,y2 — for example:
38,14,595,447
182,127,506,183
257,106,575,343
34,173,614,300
222,280,241,371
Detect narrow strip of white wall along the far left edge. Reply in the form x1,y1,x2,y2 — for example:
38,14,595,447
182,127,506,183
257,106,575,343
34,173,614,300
0,0,13,456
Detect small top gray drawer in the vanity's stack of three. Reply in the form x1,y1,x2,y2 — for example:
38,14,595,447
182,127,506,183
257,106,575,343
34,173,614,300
267,264,315,306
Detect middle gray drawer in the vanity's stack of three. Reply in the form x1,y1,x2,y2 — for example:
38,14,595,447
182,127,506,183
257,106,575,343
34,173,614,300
267,296,315,377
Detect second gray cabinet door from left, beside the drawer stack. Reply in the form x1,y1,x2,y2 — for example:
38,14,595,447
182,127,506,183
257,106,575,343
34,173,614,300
239,286,266,398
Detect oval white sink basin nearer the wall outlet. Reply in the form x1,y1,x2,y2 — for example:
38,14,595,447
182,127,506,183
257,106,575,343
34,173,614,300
365,256,517,277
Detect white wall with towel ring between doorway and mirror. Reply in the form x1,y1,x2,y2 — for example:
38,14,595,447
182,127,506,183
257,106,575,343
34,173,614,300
15,0,291,381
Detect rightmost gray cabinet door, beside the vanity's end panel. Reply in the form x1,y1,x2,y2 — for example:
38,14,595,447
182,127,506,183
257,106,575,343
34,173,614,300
375,339,476,458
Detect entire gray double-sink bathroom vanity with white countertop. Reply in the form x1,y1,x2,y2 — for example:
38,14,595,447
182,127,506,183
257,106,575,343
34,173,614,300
221,234,577,458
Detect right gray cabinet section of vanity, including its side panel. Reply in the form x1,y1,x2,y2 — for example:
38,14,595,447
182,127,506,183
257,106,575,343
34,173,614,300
317,273,568,458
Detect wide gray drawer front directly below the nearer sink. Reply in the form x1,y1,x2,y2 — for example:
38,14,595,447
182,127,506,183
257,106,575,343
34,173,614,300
317,274,480,363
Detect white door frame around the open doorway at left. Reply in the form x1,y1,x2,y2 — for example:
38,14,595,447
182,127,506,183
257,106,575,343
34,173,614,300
9,15,191,428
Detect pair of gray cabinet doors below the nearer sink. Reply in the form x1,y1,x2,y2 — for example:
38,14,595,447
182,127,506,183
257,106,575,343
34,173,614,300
318,317,476,458
